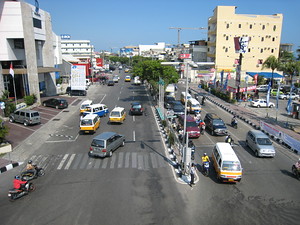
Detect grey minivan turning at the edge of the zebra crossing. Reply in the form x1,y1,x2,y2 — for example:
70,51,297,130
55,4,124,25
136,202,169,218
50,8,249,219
88,132,125,157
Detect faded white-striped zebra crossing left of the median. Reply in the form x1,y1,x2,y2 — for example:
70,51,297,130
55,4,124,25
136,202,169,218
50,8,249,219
28,152,168,171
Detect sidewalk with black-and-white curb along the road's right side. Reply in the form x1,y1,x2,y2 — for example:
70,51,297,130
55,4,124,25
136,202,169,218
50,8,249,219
189,84,300,154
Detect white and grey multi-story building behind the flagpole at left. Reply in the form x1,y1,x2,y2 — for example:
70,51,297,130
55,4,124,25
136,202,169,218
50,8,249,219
0,1,61,102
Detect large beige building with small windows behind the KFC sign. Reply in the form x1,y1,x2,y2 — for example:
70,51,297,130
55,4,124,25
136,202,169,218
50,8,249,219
207,6,283,80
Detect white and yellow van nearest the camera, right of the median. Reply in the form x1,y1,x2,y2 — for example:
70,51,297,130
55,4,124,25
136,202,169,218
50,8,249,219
212,142,242,183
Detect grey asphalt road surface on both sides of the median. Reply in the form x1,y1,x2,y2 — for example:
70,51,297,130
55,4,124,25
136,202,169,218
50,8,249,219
0,73,300,224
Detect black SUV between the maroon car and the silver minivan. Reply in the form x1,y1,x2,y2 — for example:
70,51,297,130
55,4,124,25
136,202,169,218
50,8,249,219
204,113,228,135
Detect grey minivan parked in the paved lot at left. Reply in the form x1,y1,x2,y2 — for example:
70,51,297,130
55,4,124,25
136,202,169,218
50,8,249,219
9,109,41,126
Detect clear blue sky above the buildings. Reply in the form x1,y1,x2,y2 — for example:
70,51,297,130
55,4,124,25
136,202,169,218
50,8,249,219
24,0,300,52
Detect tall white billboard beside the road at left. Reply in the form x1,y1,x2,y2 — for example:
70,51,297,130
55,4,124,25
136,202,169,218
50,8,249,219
71,65,86,90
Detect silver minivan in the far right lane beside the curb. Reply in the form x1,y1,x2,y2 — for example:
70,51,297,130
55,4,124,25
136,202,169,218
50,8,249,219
246,130,275,157
